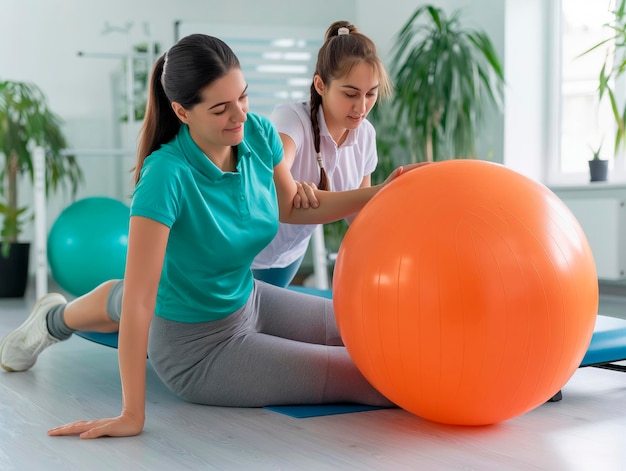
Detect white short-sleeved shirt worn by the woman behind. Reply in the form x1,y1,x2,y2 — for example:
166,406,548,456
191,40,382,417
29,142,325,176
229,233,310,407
252,102,378,269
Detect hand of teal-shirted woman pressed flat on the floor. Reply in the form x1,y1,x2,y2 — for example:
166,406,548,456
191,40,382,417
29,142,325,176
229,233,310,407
48,413,144,439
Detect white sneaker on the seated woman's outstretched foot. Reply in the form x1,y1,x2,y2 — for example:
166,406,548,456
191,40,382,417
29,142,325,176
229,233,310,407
0,293,67,371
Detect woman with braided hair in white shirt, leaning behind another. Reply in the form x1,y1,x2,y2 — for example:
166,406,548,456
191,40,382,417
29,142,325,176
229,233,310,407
252,21,391,286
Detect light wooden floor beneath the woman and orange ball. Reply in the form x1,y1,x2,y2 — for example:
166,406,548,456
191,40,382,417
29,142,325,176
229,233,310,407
0,282,626,471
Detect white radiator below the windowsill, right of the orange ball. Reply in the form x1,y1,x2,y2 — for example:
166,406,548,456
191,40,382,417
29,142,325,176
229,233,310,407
563,198,626,280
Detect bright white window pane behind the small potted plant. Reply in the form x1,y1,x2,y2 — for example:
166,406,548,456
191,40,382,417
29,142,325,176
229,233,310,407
556,0,615,180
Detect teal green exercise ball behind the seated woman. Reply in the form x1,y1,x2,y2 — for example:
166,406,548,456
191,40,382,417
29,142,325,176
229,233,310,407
48,197,130,296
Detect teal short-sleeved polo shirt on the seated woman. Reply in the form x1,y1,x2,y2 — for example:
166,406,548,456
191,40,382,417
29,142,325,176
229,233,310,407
131,113,283,322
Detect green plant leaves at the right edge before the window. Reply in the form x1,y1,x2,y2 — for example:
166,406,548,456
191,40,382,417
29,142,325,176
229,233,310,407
581,0,626,159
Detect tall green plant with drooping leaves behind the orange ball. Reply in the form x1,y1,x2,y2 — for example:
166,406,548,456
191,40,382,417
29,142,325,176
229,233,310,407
391,5,504,161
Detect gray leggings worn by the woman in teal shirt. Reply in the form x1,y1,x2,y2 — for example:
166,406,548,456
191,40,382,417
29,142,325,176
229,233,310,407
107,280,392,407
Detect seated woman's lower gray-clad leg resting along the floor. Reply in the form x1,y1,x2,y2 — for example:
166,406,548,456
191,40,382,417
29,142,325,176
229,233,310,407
197,333,391,407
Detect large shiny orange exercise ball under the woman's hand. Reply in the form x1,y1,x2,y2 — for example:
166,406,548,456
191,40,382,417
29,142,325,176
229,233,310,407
333,160,598,425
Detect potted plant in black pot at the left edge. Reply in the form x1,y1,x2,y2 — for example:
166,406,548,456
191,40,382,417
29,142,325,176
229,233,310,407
0,80,82,297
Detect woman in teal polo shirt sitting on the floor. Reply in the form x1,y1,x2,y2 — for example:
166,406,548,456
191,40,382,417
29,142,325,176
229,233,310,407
0,35,410,438
